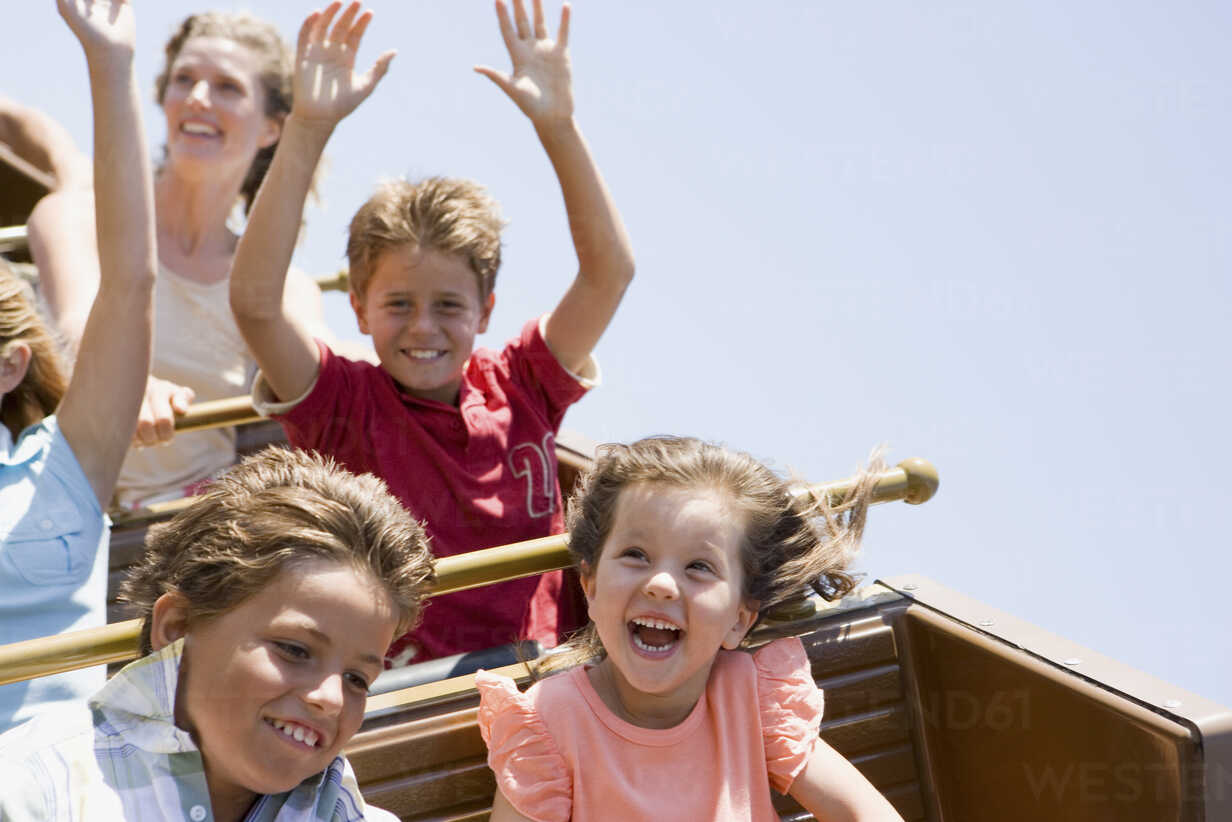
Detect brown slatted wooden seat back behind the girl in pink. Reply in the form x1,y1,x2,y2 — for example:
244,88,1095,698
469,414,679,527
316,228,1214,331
346,603,925,821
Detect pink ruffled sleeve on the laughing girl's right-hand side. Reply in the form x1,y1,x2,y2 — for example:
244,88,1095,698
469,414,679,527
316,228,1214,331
753,637,824,794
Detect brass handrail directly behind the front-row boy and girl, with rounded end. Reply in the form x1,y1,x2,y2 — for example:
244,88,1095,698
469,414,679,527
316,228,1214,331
0,457,939,685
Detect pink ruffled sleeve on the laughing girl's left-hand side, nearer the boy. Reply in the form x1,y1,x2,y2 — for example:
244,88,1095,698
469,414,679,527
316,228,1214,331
474,670,573,822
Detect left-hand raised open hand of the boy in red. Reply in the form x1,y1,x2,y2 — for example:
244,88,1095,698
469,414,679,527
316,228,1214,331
291,0,394,128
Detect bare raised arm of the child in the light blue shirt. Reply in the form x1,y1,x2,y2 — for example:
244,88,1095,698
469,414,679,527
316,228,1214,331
57,0,156,507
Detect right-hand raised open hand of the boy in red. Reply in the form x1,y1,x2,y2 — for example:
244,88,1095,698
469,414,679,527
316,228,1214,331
474,0,573,127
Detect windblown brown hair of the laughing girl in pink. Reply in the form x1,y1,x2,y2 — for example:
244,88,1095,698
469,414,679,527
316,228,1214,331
549,436,883,669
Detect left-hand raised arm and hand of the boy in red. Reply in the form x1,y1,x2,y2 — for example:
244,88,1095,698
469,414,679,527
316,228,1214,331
230,2,394,401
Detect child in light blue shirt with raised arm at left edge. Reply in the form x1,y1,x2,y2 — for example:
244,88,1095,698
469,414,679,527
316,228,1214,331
0,0,155,731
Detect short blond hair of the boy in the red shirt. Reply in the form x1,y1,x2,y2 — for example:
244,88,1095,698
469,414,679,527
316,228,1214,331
346,177,505,302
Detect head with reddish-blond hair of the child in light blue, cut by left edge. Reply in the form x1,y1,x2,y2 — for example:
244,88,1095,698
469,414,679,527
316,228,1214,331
0,264,68,440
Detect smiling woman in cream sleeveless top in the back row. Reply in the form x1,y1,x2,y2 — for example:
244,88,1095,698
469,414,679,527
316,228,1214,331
28,6,333,508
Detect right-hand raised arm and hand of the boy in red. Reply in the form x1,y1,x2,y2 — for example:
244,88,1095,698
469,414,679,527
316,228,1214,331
476,0,633,373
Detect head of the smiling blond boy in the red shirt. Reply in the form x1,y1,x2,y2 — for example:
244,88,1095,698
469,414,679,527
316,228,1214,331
346,177,501,404
